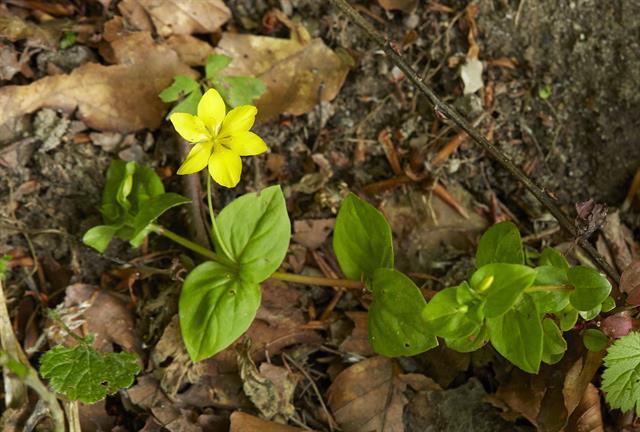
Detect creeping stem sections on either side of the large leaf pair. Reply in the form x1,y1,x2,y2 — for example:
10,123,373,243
151,225,364,289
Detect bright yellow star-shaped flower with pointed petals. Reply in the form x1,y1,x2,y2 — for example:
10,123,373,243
169,89,267,188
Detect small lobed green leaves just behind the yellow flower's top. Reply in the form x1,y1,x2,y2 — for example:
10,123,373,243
159,54,267,115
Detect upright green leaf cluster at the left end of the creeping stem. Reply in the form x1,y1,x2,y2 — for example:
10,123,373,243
82,160,190,253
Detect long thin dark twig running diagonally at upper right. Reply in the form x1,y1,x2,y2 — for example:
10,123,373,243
330,0,620,283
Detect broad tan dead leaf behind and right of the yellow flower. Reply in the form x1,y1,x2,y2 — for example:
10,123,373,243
217,33,349,121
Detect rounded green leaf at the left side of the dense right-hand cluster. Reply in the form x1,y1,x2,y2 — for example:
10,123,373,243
422,282,483,339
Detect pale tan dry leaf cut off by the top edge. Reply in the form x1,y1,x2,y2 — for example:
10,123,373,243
120,0,231,37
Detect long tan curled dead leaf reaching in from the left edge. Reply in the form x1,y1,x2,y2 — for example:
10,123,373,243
0,33,195,132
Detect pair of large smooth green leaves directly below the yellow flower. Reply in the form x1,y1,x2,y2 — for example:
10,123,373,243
179,186,291,361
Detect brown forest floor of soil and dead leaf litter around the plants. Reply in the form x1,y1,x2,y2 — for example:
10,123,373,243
0,0,640,432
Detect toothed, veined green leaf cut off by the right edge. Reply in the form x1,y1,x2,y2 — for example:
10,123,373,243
601,332,640,415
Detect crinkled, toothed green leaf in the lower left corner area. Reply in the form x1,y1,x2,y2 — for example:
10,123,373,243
40,343,140,403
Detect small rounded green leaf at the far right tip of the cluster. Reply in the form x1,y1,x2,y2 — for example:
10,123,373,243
567,266,611,311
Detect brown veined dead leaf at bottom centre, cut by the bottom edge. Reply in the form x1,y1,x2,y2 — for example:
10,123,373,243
327,357,437,432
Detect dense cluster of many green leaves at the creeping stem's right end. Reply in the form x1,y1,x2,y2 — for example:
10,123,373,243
422,222,611,373
